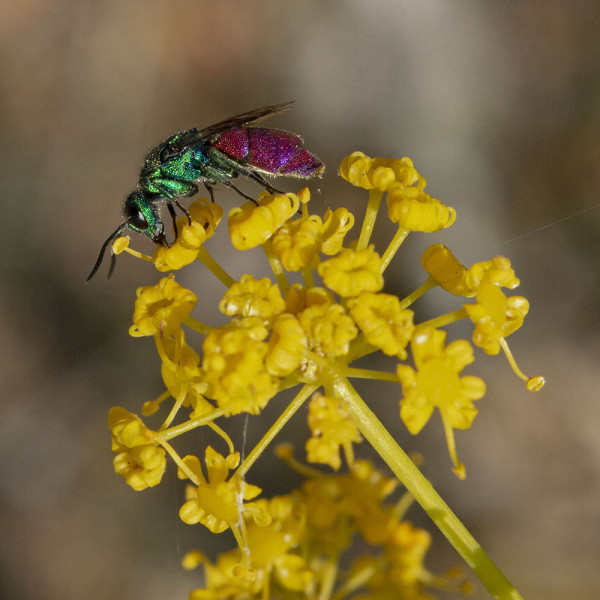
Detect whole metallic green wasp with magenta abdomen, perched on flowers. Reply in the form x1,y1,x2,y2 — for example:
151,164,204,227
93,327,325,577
86,102,325,281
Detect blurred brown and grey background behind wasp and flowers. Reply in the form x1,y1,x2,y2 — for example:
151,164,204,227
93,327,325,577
0,0,600,600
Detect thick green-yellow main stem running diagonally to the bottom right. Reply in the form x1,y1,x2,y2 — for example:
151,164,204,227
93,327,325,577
334,378,522,600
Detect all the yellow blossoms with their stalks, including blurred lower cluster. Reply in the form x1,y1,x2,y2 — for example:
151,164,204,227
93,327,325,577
109,152,544,600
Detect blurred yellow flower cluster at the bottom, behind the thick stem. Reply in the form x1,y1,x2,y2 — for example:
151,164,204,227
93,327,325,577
183,461,449,600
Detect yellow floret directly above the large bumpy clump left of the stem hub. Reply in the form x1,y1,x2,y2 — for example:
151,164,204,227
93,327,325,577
219,275,285,321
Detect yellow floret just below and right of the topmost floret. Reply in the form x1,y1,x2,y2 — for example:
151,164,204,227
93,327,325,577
387,183,456,233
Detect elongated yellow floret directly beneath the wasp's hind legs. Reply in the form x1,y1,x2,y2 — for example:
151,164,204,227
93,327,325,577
228,192,300,250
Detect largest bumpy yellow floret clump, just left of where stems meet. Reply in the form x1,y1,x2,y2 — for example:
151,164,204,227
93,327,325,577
202,317,279,415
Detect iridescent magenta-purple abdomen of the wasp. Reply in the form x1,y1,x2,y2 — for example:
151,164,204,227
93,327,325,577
211,127,324,177
